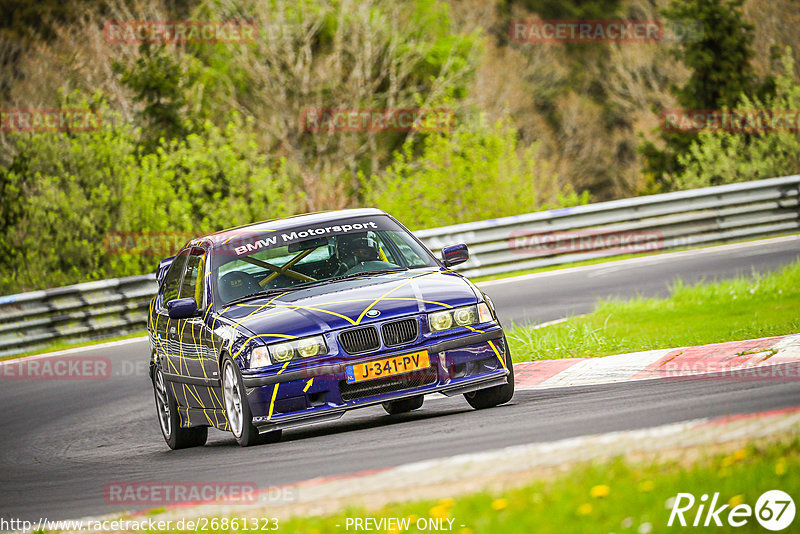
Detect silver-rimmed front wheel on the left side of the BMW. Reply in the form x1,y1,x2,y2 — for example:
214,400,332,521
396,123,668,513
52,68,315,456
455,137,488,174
220,356,281,447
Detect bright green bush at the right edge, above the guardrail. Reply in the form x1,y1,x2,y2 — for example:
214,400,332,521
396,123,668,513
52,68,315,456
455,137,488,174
675,50,800,189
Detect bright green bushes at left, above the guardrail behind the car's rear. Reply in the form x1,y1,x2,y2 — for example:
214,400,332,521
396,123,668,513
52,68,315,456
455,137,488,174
0,92,298,293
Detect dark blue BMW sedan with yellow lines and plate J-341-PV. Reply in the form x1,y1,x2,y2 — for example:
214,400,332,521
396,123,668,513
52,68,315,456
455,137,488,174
148,209,514,449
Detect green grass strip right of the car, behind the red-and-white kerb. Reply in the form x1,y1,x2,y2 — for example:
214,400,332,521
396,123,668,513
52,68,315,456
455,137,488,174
507,263,800,361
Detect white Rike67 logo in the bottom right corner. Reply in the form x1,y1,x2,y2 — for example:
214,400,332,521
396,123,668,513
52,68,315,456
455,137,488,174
667,490,795,532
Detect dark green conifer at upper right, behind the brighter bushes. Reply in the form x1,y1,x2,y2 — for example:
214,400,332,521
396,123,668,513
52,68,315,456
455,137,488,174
639,0,770,190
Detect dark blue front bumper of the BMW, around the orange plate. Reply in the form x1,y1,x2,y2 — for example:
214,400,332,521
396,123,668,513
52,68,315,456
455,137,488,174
243,327,508,432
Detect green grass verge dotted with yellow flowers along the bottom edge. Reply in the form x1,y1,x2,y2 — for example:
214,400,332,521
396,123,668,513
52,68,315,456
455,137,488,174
153,436,800,534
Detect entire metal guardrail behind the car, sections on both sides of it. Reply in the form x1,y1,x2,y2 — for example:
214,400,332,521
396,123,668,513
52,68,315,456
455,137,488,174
0,175,800,356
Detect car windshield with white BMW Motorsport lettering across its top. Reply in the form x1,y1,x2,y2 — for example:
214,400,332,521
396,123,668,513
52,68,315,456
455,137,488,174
212,216,437,305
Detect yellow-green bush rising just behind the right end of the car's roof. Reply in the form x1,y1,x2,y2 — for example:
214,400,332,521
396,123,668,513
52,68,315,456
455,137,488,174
365,121,588,229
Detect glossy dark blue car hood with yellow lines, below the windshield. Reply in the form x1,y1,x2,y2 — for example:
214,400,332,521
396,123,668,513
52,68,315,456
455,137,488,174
221,270,477,342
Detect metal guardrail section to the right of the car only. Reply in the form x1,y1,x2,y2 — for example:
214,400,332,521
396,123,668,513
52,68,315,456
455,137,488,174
415,175,800,276
